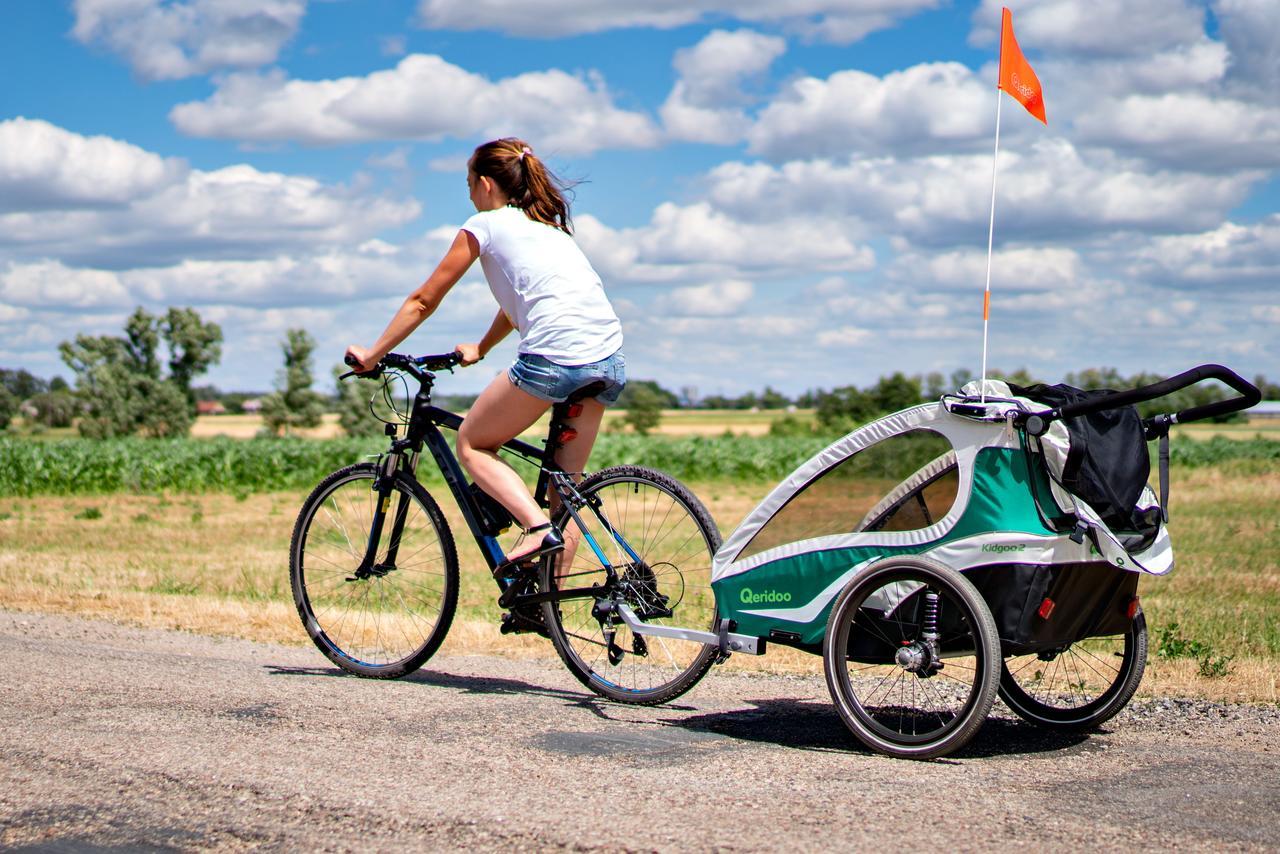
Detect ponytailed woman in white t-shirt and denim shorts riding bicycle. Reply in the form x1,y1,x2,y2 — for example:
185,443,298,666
347,137,626,572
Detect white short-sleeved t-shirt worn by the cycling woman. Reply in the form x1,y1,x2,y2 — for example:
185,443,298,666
462,206,622,365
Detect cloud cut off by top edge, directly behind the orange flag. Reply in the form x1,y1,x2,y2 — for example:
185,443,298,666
969,0,1208,58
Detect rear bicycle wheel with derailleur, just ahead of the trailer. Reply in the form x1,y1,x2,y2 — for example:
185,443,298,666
541,466,721,704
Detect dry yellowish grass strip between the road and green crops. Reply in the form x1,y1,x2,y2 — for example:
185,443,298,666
0,469,1280,702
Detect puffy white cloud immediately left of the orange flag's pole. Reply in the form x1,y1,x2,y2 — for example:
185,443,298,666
748,63,995,159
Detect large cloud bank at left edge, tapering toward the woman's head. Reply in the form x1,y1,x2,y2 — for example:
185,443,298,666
0,119,421,268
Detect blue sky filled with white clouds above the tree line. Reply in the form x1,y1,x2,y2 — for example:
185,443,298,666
0,0,1280,394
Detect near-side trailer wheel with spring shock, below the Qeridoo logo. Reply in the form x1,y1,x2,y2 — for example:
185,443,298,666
823,556,1000,759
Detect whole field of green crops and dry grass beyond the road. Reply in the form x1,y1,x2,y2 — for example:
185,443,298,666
0,419,1280,702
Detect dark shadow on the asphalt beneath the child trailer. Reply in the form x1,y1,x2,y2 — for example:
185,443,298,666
664,699,1088,762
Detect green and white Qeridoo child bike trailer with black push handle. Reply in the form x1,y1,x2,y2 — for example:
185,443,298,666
712,365,1258,758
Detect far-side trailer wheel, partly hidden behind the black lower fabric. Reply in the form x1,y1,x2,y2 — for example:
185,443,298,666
1000,611,1147,732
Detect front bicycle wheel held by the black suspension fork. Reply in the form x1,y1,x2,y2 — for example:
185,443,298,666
289,462,458,679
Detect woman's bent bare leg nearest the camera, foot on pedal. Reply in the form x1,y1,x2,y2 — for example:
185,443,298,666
457,373,550,551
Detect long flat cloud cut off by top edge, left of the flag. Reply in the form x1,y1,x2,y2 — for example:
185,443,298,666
419,0,938,44
